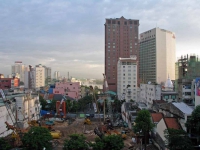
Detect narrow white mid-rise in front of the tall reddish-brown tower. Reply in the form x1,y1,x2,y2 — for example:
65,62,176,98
117,57,137,102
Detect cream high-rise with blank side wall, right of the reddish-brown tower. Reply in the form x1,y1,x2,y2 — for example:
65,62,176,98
139,28,176,84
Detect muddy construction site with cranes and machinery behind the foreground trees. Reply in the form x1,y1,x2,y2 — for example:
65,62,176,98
1,91,153,150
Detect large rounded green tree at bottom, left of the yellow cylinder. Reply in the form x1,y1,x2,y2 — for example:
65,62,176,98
22,127,52,150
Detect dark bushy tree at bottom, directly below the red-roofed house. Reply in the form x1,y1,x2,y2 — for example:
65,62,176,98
164,129,193,150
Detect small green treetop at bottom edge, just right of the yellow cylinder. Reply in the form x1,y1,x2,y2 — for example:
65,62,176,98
63,134,89,150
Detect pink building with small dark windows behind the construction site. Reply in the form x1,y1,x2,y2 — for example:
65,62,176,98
53,82,81,100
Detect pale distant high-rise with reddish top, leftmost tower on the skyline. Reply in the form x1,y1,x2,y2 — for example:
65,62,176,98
11,61,25,82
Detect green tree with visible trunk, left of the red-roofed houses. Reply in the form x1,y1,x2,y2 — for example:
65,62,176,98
133,109,154,150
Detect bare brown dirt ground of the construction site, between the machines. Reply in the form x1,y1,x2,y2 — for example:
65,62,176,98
47,119,157,150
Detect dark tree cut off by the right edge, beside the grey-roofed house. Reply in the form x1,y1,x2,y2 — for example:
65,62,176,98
185,105,200,145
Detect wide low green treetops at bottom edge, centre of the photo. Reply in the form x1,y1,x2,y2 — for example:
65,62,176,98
92,135,124,150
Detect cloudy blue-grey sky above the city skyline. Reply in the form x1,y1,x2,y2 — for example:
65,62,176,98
0,0,200,79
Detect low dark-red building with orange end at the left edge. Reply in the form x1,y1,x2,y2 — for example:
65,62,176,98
0,78,20,89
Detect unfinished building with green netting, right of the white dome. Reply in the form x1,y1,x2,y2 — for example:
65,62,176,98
175,55,200,104
